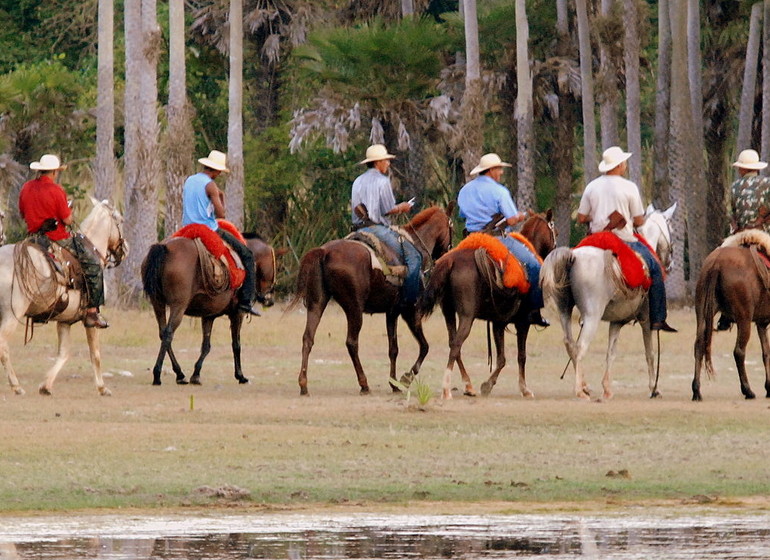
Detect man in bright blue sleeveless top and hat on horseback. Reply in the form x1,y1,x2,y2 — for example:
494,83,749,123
182,150,260,316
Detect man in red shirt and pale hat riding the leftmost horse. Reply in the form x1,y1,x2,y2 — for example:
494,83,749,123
19,154,109,329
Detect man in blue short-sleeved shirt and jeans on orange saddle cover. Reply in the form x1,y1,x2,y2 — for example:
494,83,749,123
457,154,550,327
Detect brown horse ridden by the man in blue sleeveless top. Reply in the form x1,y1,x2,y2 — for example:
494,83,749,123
142,235,286,385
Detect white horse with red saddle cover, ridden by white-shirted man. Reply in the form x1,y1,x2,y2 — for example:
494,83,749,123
540,204,676,399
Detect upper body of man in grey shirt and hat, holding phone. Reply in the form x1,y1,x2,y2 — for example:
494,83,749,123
350,144,413,230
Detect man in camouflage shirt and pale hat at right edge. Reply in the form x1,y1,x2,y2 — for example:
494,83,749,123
730,150,770,233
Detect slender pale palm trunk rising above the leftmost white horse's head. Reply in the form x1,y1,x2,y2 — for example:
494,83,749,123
94,0,116,200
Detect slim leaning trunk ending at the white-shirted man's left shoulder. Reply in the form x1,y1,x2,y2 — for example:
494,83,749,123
575,0,598,182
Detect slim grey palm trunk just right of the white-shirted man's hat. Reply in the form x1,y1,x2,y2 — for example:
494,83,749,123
624,0,642,189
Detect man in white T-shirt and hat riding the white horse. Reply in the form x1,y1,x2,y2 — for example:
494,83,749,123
577,146,676,332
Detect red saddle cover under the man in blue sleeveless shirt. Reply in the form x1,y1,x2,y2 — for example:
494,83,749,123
172,220,246,294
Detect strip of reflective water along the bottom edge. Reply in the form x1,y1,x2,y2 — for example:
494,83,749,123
0,515,770,560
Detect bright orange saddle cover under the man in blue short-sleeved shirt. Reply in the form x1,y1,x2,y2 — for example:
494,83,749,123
457,232,535,294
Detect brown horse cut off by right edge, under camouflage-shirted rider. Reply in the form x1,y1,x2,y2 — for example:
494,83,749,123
692,230,770,401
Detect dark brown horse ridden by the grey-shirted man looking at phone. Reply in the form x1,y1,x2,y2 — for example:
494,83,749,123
286,203,454,395
